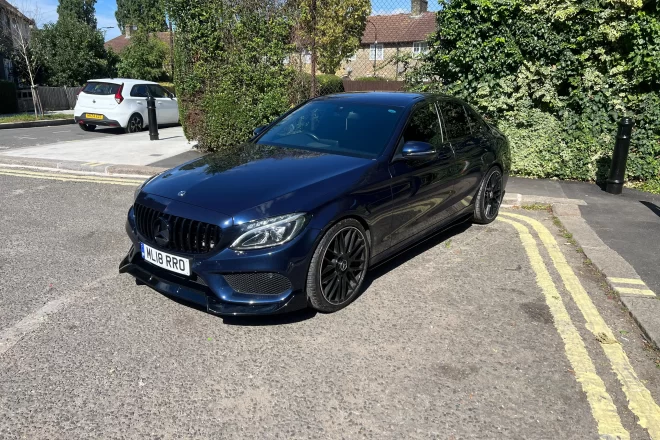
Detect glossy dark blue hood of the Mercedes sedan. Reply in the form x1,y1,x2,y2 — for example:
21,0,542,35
143,143,376,218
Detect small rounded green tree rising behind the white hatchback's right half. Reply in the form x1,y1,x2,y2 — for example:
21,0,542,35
117,28,168,81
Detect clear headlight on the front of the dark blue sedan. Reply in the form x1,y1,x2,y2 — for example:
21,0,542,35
230,213,307,250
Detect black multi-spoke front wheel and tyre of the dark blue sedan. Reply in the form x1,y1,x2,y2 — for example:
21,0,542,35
306,219,370,313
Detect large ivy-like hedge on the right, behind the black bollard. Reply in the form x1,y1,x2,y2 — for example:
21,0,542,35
407,0,660,186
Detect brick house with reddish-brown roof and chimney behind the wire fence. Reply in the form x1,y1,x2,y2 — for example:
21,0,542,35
337,0,436,80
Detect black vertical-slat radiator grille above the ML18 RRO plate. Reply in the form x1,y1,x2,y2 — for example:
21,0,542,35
133,203,221,254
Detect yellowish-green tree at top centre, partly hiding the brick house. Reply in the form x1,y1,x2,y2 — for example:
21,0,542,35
299,0,371,74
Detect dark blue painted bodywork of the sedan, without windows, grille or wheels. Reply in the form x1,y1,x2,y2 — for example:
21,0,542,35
120,93,510,315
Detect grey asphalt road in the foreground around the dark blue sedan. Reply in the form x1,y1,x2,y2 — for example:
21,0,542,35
0,170,660,440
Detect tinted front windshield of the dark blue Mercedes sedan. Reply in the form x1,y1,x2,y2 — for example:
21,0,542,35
257,101,403,158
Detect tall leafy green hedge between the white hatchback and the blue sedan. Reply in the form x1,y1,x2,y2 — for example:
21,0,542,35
167,0,299,151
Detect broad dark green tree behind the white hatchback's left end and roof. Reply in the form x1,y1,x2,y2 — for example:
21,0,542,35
36,14,115,86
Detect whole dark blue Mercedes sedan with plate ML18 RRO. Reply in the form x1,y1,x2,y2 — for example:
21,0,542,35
119,92,510,315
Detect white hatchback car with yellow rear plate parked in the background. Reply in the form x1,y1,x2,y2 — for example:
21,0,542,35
74,78,179,133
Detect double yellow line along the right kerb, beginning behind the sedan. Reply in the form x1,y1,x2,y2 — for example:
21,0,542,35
499,212,660,440
